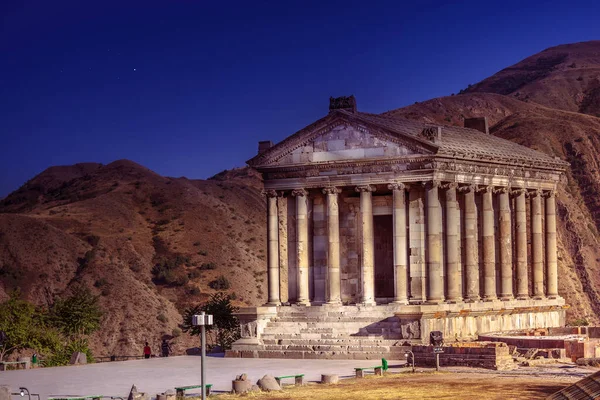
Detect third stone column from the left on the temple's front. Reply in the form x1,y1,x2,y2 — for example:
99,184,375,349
323,187,342,304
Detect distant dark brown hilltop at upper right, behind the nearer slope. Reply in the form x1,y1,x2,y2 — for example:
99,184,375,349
465,40,600,116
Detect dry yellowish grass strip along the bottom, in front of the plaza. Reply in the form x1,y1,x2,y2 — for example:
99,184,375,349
213,372,577,400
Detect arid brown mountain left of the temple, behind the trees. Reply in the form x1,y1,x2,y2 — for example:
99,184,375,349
0,160,266,355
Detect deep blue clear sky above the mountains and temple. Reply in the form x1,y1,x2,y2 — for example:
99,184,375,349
0,0,600,198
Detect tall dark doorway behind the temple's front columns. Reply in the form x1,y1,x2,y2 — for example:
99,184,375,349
373,215,394,299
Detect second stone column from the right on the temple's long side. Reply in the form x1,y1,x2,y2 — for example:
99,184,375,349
530,190,544,299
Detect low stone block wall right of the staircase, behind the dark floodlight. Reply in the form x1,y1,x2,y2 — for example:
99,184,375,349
412,342,515,370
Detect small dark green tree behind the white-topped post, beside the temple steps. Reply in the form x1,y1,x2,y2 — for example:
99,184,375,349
181,292,240,350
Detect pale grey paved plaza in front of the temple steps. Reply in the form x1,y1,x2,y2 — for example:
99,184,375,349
0,356,404,399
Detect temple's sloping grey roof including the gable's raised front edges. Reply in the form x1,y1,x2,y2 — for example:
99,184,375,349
248,109,568,170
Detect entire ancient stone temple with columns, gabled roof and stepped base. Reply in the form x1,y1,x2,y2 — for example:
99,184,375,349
228,96,568,358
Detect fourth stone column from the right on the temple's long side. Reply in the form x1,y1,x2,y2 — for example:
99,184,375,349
496,187,513,300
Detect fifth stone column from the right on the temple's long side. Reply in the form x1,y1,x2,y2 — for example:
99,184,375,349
482,186,498,301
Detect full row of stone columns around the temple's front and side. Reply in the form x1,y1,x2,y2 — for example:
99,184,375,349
265,181,558,305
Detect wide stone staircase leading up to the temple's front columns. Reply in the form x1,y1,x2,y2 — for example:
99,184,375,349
227,305,405,360
